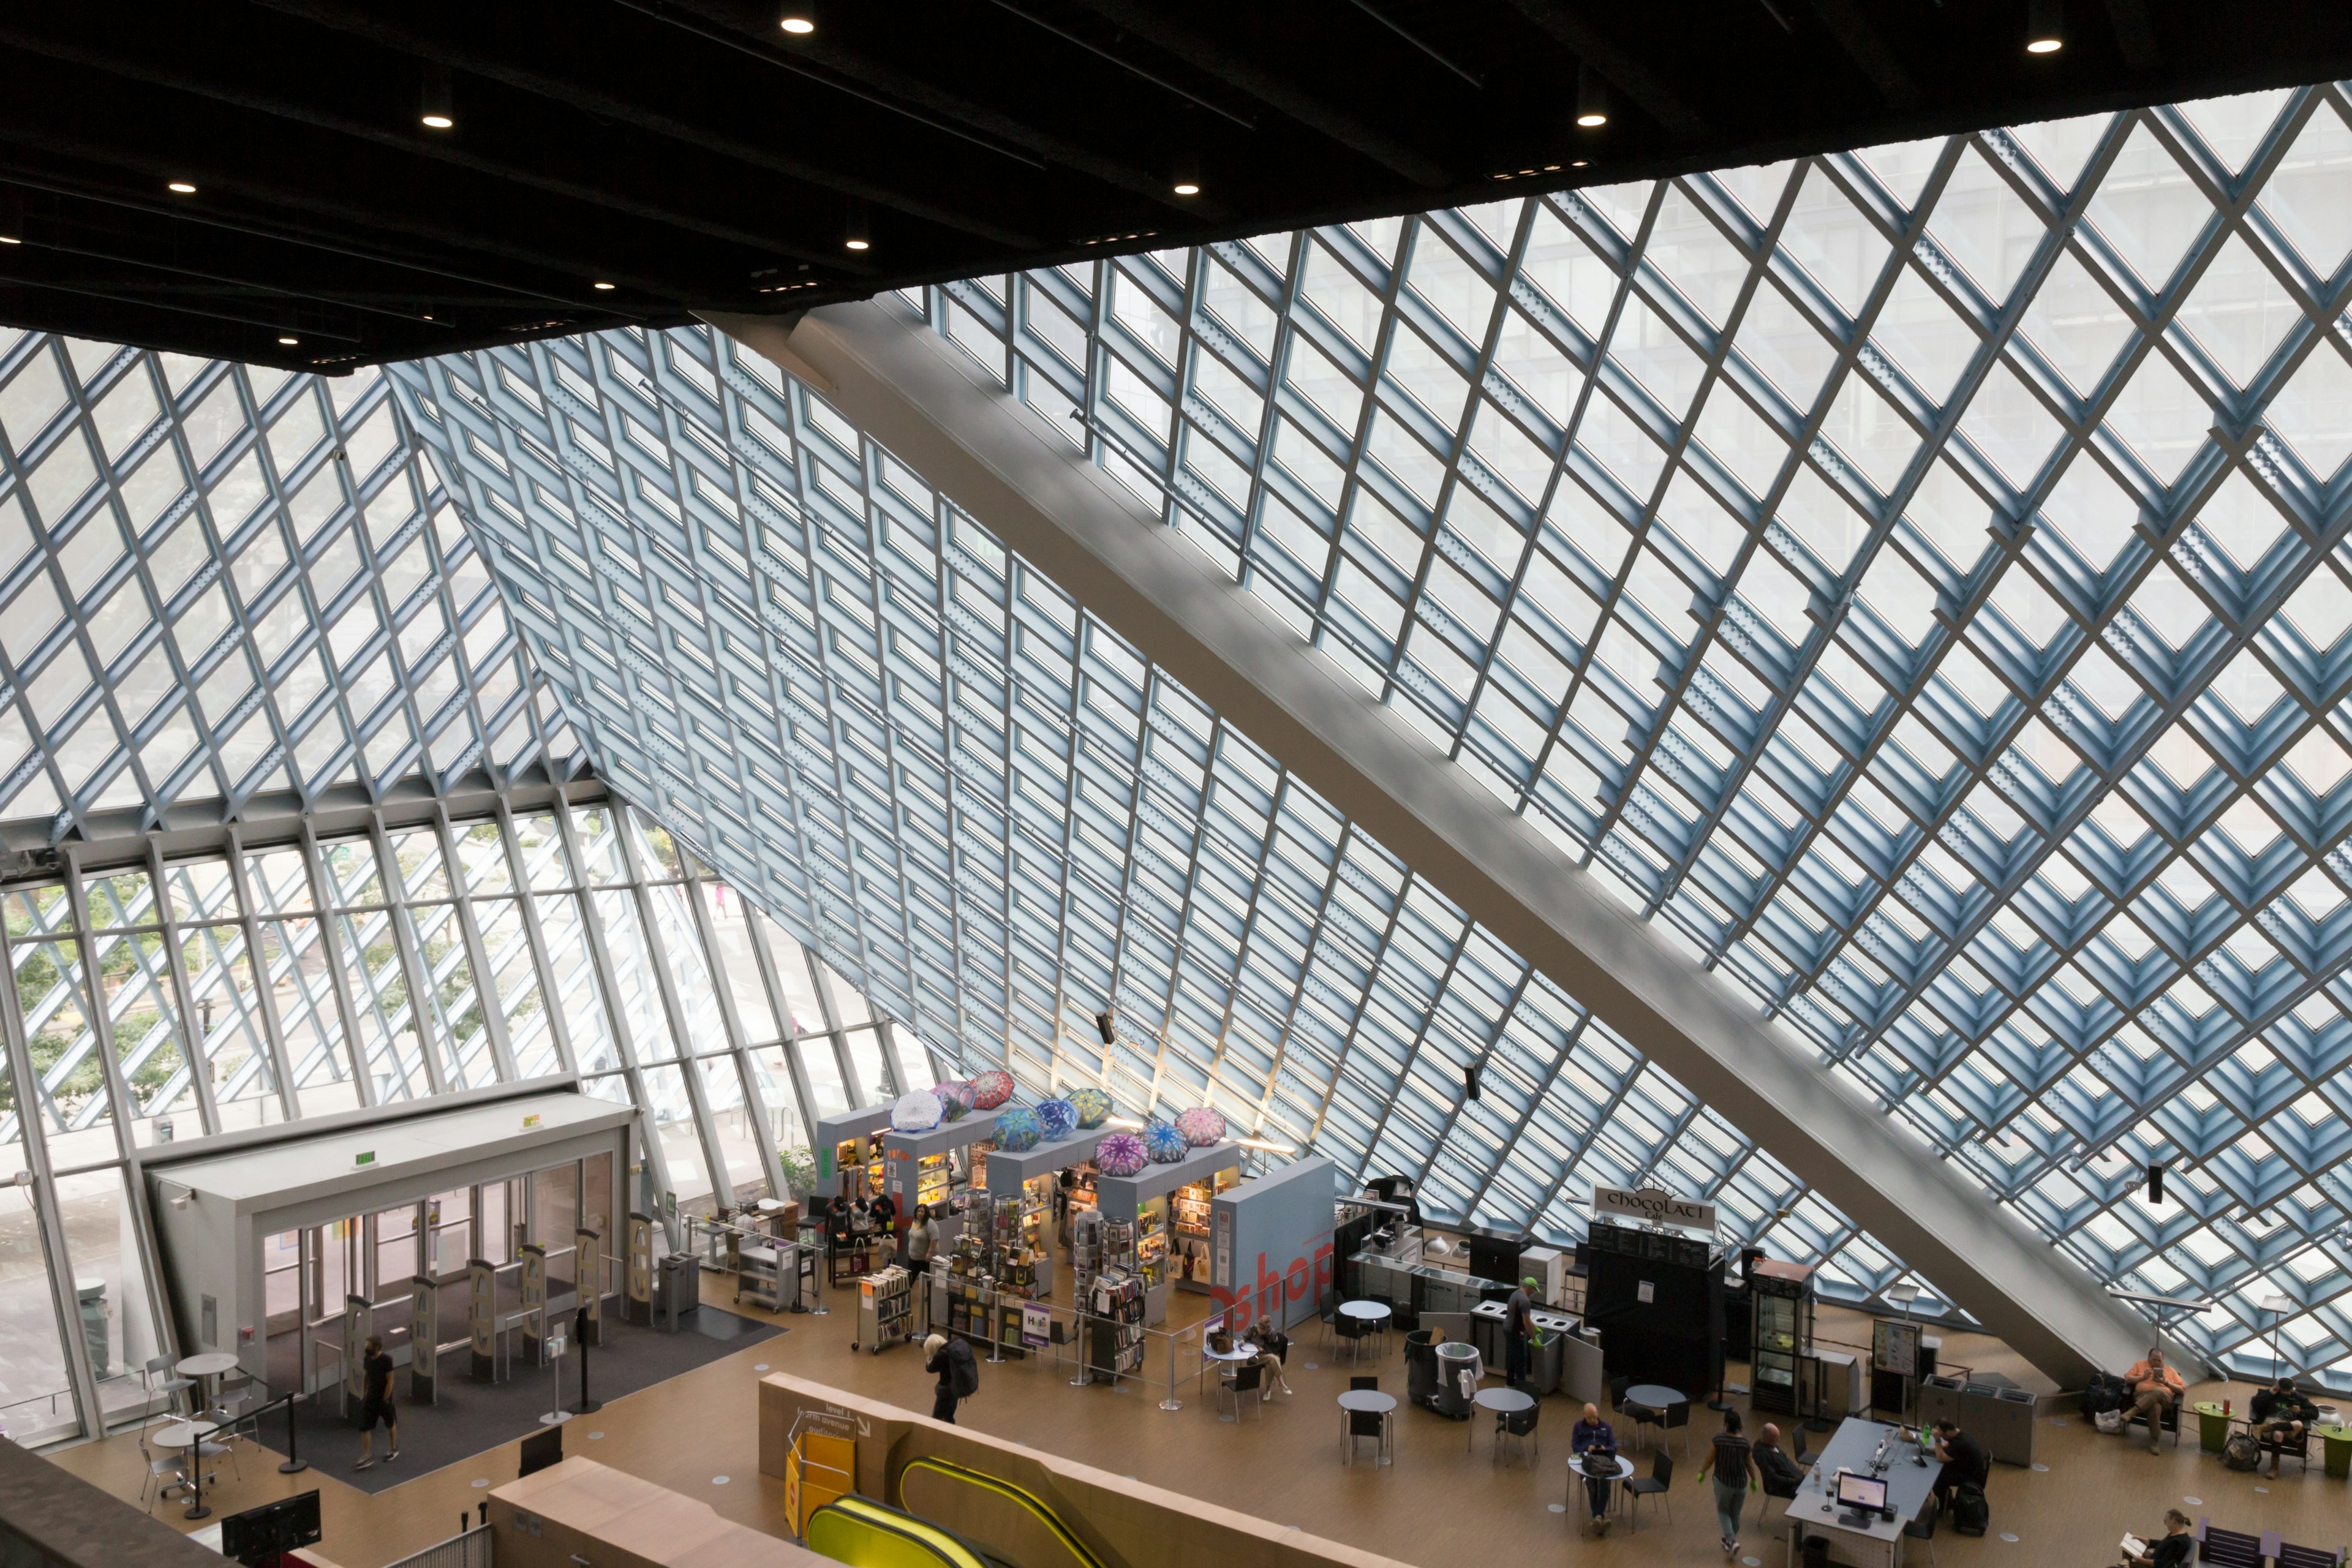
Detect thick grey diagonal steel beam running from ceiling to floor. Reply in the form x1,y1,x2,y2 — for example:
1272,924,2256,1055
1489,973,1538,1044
710,303,2182,1387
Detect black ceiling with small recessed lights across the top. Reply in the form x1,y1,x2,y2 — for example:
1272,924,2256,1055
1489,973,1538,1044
0,0,2352,369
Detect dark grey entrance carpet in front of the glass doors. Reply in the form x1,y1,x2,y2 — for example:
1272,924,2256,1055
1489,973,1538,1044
240,1307,783,1493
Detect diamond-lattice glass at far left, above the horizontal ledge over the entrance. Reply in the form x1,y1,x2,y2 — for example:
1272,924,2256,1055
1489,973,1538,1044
0,326,576,839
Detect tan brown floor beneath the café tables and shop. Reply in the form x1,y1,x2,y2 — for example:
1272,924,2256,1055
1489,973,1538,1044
56,1276,2352,1568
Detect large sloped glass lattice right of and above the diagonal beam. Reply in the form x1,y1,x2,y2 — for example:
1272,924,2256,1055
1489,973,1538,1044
884,87,2352,1363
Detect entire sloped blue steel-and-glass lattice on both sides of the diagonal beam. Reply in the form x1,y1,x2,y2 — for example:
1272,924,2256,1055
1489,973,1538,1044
400,85,2352,1378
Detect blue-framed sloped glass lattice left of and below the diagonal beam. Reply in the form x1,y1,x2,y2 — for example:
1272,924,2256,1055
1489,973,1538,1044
395,331,1928,1298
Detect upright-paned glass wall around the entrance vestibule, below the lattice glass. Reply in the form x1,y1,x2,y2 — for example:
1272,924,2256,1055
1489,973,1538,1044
0,785,901,1444
